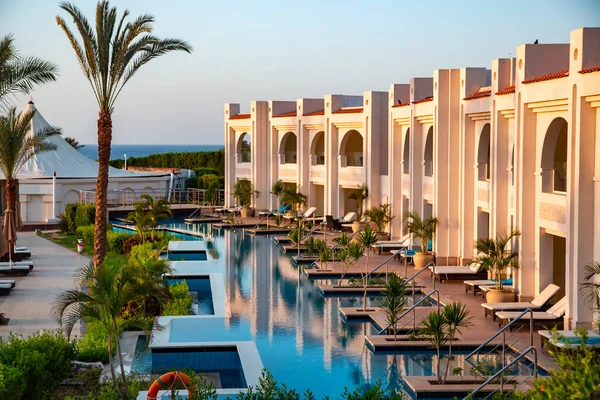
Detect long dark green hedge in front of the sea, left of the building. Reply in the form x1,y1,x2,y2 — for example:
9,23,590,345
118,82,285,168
110,149,225,175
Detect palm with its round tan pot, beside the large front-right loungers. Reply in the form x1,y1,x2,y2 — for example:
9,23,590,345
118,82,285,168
469,230,521,303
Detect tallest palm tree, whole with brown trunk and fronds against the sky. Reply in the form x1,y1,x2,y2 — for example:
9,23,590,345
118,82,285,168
56,1,192,267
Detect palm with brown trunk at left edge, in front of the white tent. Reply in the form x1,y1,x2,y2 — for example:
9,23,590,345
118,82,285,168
0,108,60,252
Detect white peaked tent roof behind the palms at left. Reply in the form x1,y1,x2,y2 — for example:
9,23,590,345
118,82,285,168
0,101,167,179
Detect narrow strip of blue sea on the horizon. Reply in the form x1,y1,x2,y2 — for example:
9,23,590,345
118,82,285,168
79,144,224,160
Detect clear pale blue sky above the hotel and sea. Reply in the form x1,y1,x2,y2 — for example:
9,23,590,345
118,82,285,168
0,0,600,144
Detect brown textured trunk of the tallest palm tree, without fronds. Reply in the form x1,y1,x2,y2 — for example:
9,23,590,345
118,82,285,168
94,111,112,268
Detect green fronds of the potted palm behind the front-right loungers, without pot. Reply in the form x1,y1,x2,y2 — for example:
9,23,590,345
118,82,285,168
469,230,521,290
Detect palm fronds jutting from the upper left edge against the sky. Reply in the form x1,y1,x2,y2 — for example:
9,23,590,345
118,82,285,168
0,35,58,110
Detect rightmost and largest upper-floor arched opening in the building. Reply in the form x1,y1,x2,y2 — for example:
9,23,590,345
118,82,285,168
541,117,568,193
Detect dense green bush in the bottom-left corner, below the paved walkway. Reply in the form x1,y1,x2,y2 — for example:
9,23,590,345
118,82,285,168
0,331,75,400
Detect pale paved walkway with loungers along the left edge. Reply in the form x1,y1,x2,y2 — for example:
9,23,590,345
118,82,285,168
0,232,90,338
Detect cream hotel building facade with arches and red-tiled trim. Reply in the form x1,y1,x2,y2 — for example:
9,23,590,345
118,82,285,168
224,28,600,327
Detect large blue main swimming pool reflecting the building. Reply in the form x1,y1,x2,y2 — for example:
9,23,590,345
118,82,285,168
138,230,540,399
